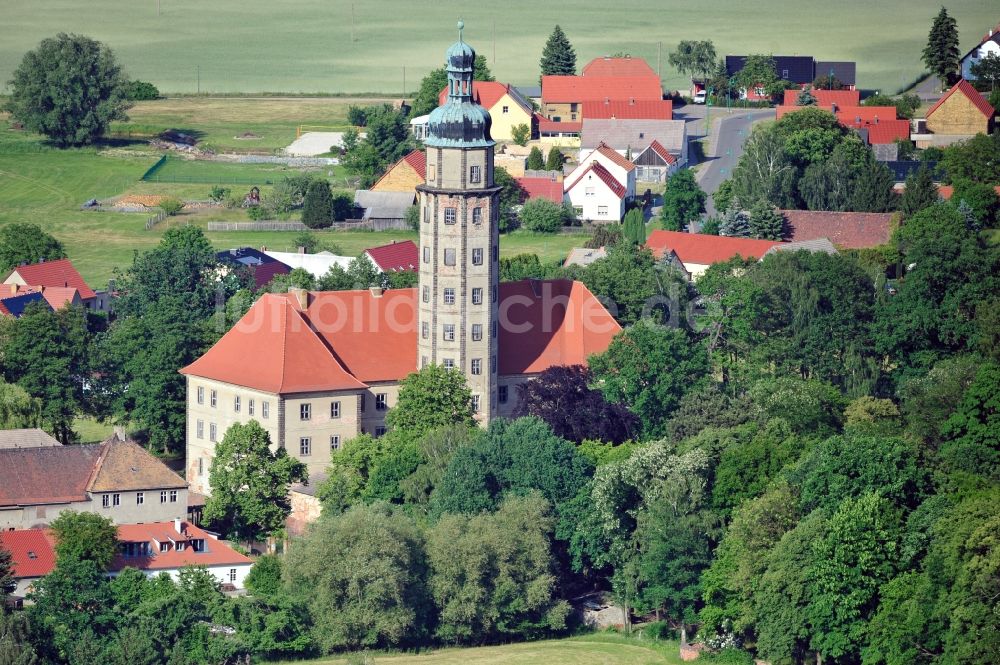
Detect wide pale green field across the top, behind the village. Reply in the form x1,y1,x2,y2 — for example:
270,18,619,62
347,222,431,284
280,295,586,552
0,0,997,94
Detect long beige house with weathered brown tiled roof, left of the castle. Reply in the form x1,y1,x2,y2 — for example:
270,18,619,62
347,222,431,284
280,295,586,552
0,437,188,529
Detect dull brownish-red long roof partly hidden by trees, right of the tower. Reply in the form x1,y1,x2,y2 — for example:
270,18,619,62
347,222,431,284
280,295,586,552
781,210,892,249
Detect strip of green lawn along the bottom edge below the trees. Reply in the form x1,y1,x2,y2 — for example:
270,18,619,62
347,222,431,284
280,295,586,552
268,633,682,665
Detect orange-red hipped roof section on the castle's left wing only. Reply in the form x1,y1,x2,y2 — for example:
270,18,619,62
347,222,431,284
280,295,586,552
180,293,365,394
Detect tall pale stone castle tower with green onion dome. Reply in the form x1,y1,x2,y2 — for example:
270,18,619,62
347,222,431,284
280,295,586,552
417,21,500,423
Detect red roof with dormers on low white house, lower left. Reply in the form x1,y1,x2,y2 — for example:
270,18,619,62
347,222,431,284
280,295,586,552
110,521,253,571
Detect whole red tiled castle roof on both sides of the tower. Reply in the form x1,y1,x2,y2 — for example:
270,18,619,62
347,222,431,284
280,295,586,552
181,280,620,392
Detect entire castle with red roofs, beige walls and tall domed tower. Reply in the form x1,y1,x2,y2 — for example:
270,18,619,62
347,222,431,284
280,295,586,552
181,24,621,493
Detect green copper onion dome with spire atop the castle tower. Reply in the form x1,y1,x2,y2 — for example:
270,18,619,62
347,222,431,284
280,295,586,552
425,21,495,148
